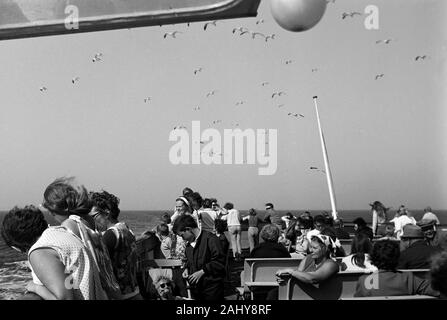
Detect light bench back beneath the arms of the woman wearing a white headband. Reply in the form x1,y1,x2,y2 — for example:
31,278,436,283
278,269,429,300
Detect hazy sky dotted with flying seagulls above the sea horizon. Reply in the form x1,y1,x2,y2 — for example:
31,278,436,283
0,0,447,210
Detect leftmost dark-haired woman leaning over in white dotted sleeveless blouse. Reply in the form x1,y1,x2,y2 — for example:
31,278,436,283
1,206,107,300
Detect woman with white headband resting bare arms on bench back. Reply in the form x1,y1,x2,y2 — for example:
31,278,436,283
276,234,339,284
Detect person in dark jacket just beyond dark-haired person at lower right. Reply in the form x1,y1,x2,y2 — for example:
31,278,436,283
398,224,439,269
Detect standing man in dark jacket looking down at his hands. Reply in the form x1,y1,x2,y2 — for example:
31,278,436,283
173,215,225,301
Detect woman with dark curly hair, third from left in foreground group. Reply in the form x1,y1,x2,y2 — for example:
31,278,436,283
90,190,142,300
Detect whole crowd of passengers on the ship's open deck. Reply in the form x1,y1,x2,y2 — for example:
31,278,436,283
1,178,447,301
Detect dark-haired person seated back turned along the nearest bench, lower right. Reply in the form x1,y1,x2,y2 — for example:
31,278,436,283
354,240,439,297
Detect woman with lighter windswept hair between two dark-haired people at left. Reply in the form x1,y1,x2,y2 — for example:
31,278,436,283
40,177,122,299
